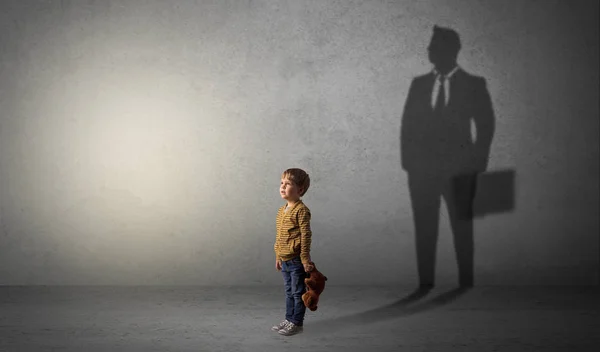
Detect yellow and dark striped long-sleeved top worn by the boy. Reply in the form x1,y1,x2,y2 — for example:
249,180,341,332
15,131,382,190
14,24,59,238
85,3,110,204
274,200,312,264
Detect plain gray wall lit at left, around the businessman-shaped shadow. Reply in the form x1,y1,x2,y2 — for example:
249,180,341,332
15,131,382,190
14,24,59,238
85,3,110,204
0,0,599,285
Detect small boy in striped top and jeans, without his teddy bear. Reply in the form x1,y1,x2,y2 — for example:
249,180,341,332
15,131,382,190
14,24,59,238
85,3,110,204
272,168,313,336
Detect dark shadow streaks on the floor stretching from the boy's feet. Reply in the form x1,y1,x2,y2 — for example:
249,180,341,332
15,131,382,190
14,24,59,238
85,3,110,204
310,287,469,335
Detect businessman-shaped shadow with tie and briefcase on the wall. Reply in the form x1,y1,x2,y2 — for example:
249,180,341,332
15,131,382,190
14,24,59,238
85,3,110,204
400,26,514,287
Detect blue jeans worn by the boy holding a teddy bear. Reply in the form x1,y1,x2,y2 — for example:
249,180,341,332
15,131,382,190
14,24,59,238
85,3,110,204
281,257,306,326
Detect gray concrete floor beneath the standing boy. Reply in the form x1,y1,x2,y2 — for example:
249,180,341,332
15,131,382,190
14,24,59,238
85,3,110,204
0,286,600,352
